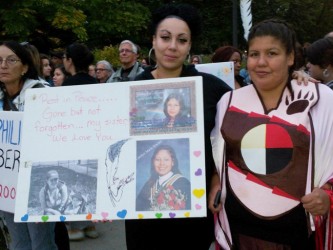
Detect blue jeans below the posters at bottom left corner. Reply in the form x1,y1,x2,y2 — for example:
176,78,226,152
2,212,58,250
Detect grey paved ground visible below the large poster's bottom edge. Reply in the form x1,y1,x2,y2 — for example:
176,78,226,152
70,220,127,250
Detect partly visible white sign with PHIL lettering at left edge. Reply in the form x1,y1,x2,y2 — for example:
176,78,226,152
0,111,23,213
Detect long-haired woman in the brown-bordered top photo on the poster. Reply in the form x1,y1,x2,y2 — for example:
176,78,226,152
159,93,195,128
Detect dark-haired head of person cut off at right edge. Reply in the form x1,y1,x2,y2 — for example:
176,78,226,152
306,37,333,89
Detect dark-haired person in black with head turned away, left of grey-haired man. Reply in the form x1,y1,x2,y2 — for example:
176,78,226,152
62,43,97,86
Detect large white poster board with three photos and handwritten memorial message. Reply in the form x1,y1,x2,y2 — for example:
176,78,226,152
15,77,207,222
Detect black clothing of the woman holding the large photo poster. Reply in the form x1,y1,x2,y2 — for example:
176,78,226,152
125,65,231,250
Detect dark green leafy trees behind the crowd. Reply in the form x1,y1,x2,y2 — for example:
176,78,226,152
0,0,333,70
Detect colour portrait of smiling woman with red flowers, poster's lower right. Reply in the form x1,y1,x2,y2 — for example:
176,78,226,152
136,139,191,211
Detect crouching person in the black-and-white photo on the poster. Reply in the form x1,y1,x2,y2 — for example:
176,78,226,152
39,170,68,215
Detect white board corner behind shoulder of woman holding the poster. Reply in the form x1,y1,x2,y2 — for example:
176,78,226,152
195,62,235,89
